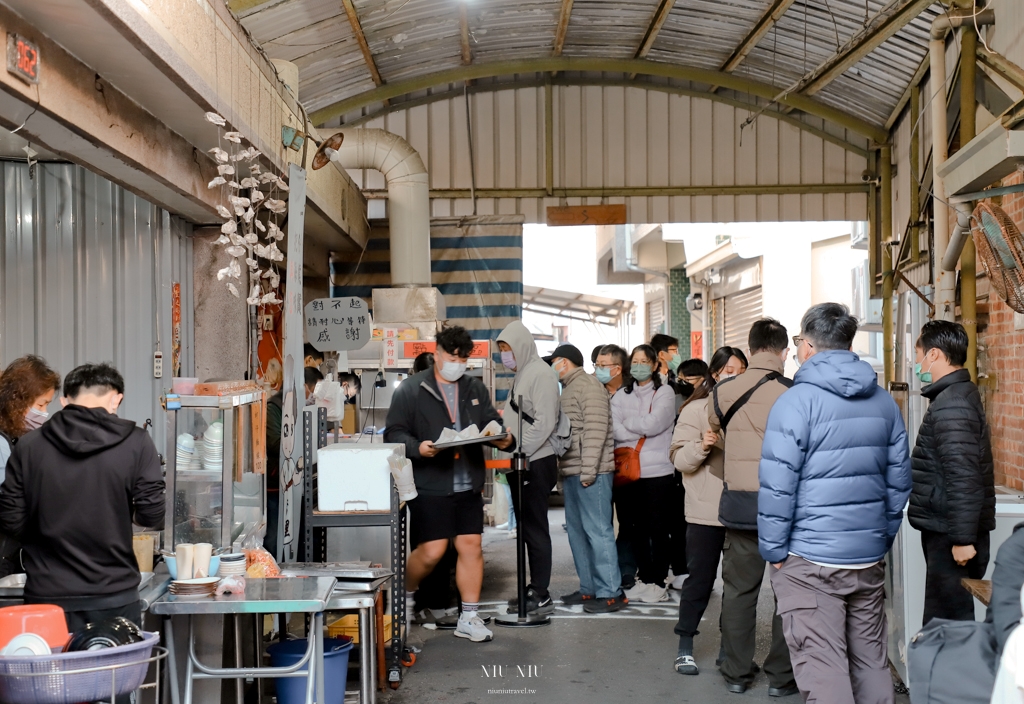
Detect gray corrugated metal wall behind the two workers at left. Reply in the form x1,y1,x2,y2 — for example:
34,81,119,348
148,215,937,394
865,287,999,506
0,162,193,451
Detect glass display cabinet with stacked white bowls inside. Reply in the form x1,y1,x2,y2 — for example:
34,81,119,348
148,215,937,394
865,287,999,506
163,390,266,551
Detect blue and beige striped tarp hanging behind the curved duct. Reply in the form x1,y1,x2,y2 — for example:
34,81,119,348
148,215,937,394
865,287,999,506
331,216,522,401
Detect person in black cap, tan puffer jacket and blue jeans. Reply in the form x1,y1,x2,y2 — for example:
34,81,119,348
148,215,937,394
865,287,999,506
544,345,627,613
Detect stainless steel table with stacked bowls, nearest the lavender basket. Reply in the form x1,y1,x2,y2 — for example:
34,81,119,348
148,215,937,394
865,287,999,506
150,577,335,704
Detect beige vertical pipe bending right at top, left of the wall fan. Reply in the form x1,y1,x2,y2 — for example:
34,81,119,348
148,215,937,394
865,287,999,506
929,10,995,321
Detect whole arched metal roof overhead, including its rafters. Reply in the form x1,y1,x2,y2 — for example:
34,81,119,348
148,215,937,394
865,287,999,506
235,0,943,140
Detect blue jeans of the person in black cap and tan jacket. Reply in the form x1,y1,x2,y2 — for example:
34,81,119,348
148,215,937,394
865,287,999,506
562,474,622,599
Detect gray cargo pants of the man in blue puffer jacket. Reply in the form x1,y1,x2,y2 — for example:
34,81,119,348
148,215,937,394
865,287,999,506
771,555,894,704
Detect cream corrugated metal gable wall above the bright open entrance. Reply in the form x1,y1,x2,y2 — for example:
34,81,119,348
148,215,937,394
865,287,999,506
350,86,867,223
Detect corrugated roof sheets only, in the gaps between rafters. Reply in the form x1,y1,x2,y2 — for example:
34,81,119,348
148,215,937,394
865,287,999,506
241,0,941,130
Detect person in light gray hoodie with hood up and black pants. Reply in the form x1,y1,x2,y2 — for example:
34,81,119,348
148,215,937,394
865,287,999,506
498,320,560,614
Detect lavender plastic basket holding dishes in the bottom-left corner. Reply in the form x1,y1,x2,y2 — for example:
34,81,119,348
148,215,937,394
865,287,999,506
0,633,160,704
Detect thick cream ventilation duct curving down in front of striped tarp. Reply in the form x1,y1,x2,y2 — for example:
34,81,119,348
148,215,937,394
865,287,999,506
326,129,430,289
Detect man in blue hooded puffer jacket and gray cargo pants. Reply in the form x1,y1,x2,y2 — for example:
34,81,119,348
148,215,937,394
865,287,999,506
758,303,910,704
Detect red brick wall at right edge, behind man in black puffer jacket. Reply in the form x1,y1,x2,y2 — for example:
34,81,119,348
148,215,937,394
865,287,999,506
978,172,1024,489
